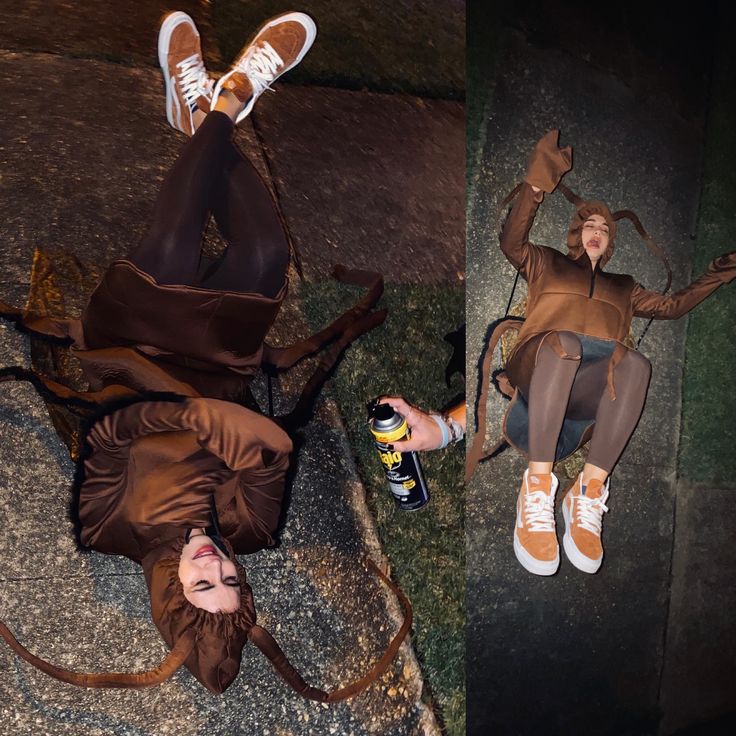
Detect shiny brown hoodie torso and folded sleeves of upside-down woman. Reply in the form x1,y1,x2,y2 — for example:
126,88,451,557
79,398,292,562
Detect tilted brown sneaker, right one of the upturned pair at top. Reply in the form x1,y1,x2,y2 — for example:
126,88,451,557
212,13,317,123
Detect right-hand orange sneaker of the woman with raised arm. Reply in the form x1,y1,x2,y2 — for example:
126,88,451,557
562,473,609,573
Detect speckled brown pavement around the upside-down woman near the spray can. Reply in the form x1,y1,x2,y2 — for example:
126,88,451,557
0,1,464,736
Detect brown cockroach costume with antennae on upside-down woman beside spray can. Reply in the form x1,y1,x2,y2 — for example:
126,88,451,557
0,261,402,688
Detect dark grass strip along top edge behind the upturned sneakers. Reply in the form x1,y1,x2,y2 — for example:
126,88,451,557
0,0,465,100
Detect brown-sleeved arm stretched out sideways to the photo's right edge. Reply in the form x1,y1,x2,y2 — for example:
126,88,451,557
631,251,736,319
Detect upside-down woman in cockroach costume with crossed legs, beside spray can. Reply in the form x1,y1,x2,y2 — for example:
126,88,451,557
0,12,410,701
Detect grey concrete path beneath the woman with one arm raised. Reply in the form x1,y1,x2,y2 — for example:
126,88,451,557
466,25,734,736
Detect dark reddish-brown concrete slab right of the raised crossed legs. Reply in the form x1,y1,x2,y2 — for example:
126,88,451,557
254,86,465,284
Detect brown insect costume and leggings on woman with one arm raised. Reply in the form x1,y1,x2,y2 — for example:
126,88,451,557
466,131,736,478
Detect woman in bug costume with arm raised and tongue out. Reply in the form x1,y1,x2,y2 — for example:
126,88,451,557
468,131,736,575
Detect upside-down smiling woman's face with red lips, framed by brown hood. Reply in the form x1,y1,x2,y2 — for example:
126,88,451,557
179,530,240,613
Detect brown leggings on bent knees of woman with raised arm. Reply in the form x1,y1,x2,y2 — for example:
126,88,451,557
519,332,652,473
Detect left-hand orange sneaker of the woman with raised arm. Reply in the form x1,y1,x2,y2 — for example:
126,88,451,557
514,470,560,575
